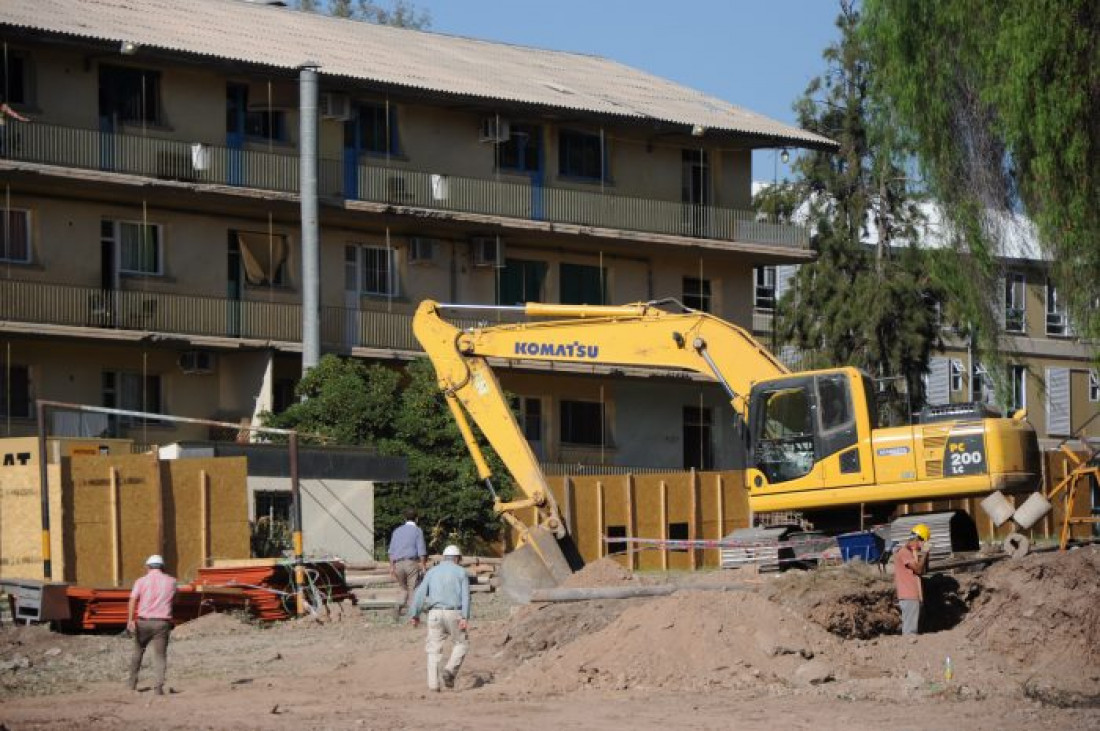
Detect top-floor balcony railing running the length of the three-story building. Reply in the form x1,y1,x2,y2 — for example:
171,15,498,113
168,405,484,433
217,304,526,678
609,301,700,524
0,122,810,251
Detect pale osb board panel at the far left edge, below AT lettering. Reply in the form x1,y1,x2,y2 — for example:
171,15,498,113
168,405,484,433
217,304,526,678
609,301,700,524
0,465,65,579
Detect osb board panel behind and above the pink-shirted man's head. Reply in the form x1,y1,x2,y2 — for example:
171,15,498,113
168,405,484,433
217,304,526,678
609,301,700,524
64,454,163,586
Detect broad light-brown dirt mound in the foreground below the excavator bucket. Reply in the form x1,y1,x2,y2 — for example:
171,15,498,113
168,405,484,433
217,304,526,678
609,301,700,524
507,590,837,691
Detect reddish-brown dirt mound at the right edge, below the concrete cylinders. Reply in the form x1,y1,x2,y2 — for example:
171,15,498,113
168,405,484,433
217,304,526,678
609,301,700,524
959,546,1100,702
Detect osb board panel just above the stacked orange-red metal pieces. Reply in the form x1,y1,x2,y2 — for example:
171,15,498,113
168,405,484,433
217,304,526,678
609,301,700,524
161,457,251,580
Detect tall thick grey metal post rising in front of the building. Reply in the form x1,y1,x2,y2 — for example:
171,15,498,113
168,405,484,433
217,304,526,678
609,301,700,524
298,63,321,375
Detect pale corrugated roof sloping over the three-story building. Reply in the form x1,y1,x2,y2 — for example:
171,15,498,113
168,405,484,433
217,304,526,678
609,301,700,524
0,0,835,147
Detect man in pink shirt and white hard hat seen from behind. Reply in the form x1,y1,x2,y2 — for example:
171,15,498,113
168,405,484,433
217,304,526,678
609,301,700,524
127,554,176,696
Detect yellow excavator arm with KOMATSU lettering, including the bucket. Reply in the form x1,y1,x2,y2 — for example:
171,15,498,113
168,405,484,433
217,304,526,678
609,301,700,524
413,300,789,596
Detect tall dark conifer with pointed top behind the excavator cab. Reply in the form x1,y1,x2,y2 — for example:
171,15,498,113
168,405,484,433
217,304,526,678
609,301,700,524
763,0,938,417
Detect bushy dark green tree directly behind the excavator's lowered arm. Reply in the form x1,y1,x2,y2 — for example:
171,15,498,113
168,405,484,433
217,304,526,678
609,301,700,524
264,355,512,550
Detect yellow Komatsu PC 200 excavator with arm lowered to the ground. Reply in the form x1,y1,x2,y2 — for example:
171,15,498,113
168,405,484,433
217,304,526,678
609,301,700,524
413,300,1041,597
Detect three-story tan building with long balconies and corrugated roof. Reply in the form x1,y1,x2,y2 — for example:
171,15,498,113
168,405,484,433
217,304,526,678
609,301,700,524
0,0,833,468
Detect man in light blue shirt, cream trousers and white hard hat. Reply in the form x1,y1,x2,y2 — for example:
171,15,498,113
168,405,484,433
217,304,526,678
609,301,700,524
409,545,470,691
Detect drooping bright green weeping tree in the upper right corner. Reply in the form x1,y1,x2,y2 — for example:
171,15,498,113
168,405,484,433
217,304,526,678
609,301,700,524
862,0,1100,357
